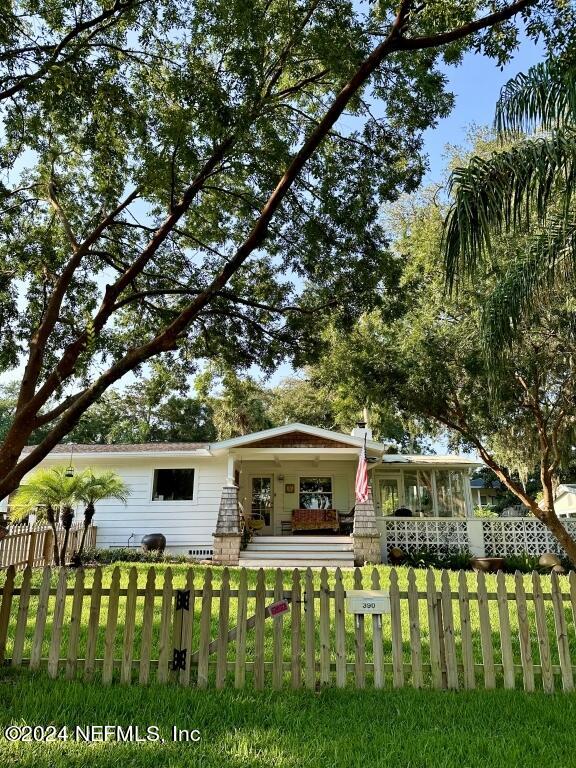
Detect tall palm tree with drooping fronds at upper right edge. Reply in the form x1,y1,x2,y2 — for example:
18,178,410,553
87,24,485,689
443,55,576,350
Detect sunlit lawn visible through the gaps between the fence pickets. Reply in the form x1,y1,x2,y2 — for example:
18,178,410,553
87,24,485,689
2,564,576,686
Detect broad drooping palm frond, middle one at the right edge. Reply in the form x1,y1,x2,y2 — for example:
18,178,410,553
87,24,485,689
442,128,576,288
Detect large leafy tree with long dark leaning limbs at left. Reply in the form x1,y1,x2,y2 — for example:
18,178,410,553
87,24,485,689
0,0,574,498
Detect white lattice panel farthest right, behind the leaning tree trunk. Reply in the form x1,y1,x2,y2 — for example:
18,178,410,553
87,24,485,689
482,517,576,557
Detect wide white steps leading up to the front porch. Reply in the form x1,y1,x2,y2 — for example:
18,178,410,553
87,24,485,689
239,536,354,568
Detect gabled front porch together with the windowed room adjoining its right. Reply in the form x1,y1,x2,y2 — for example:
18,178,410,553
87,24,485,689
209,425,477,562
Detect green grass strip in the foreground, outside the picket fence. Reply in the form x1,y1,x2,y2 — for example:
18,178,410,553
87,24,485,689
0,671,576,768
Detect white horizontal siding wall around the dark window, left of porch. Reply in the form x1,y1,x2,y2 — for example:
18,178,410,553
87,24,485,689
18,455,226,554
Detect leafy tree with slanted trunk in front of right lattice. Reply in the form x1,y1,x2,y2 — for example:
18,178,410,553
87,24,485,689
310,177,576,563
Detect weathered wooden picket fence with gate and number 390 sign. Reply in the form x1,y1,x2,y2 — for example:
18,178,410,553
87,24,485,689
0,567,576,692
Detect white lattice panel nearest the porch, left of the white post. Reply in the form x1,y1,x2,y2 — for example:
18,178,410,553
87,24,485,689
384,518,470,552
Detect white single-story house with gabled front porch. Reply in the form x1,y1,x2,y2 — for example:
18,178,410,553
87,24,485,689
6,423,479,563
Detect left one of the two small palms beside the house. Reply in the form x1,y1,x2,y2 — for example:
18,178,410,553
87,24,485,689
10,467,82,565
